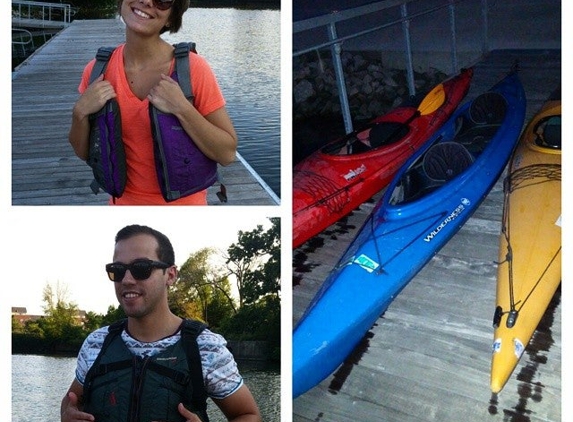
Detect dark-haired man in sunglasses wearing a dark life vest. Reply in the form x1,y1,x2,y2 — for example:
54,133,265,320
61,225,261,422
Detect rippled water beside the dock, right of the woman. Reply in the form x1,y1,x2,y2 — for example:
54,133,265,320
164,8,280,197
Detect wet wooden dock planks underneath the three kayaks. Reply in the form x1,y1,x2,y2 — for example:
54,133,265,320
292,50,566,422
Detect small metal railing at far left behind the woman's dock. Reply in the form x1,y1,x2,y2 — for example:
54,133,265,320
12,0,72,27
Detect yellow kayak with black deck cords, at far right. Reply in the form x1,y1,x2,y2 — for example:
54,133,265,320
491,91,561,393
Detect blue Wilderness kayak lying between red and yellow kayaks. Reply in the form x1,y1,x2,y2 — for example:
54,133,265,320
293,72,525,397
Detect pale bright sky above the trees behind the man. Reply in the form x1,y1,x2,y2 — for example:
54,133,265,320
2,206,277,315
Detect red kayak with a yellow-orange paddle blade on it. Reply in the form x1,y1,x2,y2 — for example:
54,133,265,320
293,69,473,248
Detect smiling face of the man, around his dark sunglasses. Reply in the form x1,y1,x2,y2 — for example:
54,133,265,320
113,234,176,318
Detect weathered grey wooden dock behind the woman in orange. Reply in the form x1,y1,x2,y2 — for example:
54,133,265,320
12,19,280,205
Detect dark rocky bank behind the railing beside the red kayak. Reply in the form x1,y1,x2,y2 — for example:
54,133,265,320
293,52,447,163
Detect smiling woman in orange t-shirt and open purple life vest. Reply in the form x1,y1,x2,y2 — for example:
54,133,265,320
69,0,237,205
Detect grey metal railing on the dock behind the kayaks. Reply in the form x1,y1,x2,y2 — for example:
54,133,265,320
293,0,489,133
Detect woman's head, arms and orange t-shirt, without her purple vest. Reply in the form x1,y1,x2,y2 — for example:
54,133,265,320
69,0,237,205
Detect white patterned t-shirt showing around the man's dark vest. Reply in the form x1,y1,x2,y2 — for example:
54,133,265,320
76,327,243,399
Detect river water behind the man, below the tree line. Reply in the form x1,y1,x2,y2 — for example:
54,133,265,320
12,355,280,422
